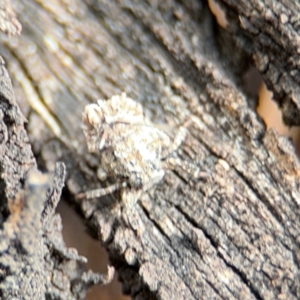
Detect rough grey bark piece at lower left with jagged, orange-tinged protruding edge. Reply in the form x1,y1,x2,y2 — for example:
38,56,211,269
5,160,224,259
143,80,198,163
0,49,113,299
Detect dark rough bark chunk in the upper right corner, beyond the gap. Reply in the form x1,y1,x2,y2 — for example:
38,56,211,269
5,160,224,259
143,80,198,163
218,0,300,126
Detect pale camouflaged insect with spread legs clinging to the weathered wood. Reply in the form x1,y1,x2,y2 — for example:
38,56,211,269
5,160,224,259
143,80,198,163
77,93,199,206
